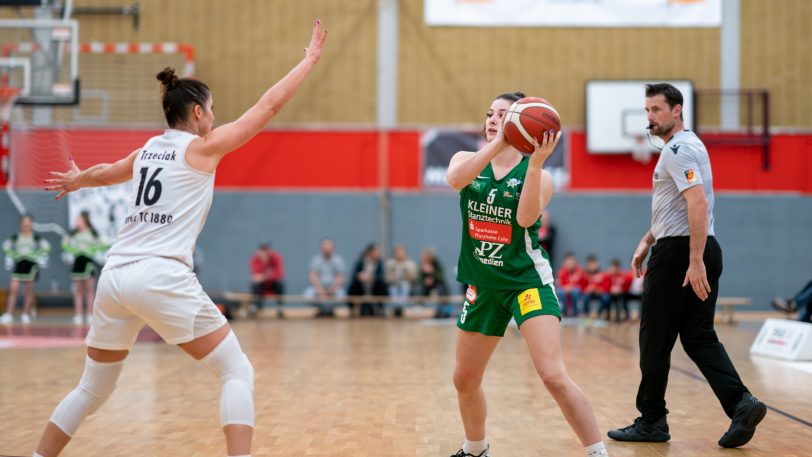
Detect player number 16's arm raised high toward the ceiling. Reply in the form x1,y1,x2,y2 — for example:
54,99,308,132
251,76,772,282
190,21,327,159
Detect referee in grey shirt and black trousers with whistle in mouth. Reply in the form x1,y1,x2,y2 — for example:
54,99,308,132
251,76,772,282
609,83,767,448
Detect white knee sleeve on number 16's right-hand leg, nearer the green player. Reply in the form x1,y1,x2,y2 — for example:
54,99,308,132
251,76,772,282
200,332,254,427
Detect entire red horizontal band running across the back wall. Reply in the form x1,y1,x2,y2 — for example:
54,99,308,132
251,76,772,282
0,129,812,194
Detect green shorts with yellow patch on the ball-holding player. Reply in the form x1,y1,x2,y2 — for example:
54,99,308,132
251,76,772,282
457,284,561,336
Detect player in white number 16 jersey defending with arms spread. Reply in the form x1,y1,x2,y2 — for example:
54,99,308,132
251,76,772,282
34,21,327,457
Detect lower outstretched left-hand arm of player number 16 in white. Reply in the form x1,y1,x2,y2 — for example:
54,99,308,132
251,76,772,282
45,148,141,200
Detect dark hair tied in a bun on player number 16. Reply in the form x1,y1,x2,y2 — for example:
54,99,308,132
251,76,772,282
155,67,211,127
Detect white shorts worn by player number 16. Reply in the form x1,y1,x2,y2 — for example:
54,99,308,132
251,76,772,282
86,257,227,350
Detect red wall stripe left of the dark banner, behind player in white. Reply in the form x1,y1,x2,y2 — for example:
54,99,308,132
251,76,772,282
7,129,420,190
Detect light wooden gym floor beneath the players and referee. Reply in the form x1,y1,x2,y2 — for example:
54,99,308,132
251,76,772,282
0,318,812,457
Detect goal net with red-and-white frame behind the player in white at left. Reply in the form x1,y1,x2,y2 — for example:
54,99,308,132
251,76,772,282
7,44,191,234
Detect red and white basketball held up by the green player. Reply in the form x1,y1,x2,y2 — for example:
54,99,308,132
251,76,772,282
503,97,561,154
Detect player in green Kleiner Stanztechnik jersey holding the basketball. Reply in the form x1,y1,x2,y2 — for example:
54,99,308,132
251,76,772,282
448,92,608,457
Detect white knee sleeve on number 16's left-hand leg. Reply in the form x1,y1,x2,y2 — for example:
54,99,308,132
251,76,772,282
50,357,124,437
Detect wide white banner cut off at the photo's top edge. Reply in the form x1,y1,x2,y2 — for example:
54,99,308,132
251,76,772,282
424,0,722,27
